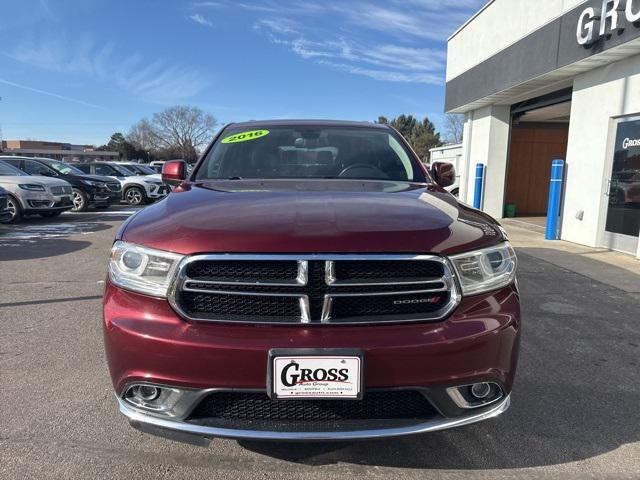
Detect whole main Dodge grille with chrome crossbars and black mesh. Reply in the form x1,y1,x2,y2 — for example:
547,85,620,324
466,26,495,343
171,255,458,324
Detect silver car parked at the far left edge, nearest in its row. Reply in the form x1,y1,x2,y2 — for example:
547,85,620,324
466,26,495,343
0,161,73,223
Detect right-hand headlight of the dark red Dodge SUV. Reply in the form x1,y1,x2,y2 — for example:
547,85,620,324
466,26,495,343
449,242,517,295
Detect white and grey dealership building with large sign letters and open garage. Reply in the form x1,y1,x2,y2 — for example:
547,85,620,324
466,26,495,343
446,0,640,258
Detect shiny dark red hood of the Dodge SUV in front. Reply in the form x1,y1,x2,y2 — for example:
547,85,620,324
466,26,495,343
118,180,504,254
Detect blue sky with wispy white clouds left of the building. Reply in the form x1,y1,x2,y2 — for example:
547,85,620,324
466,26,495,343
0,0,484,144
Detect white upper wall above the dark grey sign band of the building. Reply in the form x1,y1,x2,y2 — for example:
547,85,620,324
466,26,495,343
447,0,584,81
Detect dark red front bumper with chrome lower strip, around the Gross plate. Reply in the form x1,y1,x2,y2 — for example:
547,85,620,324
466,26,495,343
104,282,520,440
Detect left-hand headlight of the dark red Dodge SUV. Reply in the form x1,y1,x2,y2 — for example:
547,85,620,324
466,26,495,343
109,241,184,297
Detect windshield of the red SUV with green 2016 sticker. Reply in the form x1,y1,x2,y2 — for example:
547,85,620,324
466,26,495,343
196,126,426,182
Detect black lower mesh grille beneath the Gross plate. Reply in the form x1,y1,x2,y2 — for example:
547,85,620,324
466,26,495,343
188,390,436,422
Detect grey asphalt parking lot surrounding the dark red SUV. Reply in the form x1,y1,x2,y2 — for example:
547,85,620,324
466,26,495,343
0,211,640,479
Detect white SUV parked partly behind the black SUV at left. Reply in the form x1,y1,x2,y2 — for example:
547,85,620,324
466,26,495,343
75,162,171,205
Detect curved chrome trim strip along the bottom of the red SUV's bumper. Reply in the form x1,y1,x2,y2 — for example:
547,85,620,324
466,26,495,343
118,396,511,441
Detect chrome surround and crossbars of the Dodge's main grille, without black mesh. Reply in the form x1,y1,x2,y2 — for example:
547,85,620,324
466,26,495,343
167,254,462,325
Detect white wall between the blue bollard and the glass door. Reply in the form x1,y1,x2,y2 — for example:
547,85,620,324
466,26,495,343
561,52,640,257
